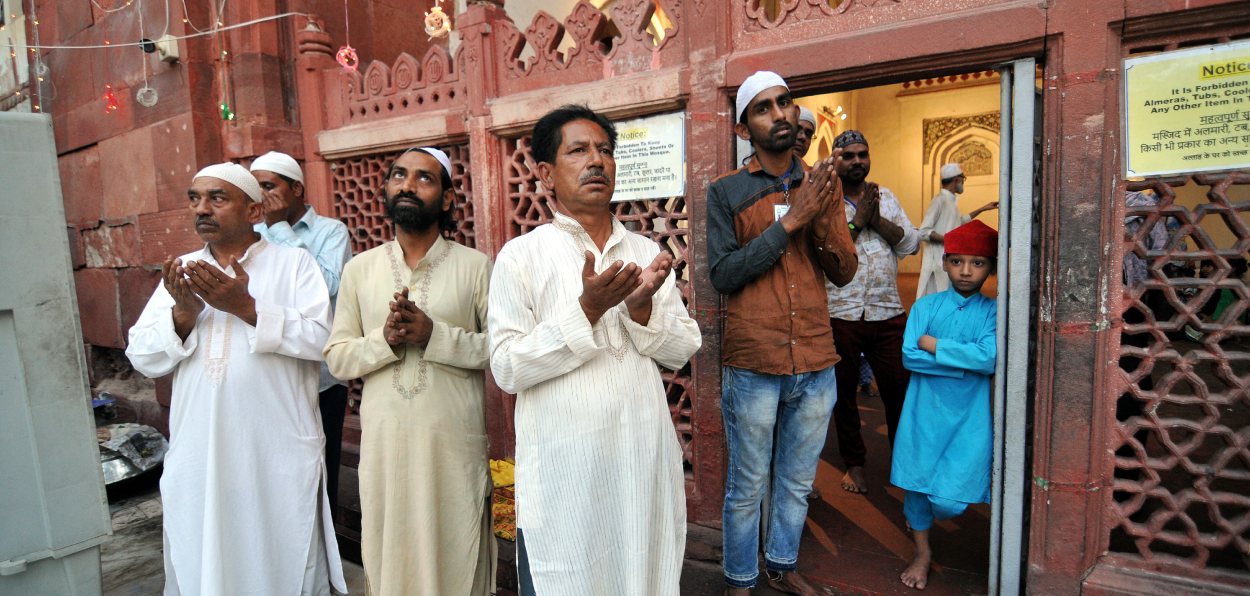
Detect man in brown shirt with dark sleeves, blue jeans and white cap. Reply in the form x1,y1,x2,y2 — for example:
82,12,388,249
708,71,856,595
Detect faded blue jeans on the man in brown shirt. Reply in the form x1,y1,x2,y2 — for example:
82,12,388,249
720,366,838,587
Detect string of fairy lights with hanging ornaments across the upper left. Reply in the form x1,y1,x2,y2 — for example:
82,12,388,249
0,0,451,121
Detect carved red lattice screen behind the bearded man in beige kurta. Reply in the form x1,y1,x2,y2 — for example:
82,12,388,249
330,145,476,415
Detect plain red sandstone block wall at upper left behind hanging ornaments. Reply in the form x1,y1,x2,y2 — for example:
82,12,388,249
36,0,445,429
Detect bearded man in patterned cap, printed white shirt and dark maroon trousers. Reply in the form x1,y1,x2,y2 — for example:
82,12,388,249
826,130,920,494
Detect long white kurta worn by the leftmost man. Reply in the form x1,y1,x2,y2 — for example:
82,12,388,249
126,240,346,596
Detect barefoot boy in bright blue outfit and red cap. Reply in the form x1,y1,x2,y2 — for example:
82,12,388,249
890,220,999,590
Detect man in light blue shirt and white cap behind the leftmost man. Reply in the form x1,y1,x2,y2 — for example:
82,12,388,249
251,151,351,515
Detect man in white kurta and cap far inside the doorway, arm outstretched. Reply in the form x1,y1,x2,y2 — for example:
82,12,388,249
916,164,999,300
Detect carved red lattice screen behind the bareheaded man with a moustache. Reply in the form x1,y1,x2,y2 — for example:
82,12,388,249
504,136,694,474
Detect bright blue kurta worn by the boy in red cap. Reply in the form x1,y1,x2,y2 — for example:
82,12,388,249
890,287,999,502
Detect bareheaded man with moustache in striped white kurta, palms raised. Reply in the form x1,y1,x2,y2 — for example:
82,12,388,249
488,106,701,596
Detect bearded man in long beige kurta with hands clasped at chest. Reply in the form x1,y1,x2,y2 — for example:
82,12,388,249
325,147,495,596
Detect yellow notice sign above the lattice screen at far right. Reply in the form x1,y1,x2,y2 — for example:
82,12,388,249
1124,41,1250,177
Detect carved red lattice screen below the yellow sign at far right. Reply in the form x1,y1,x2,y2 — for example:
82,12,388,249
1109,172,1250,572
